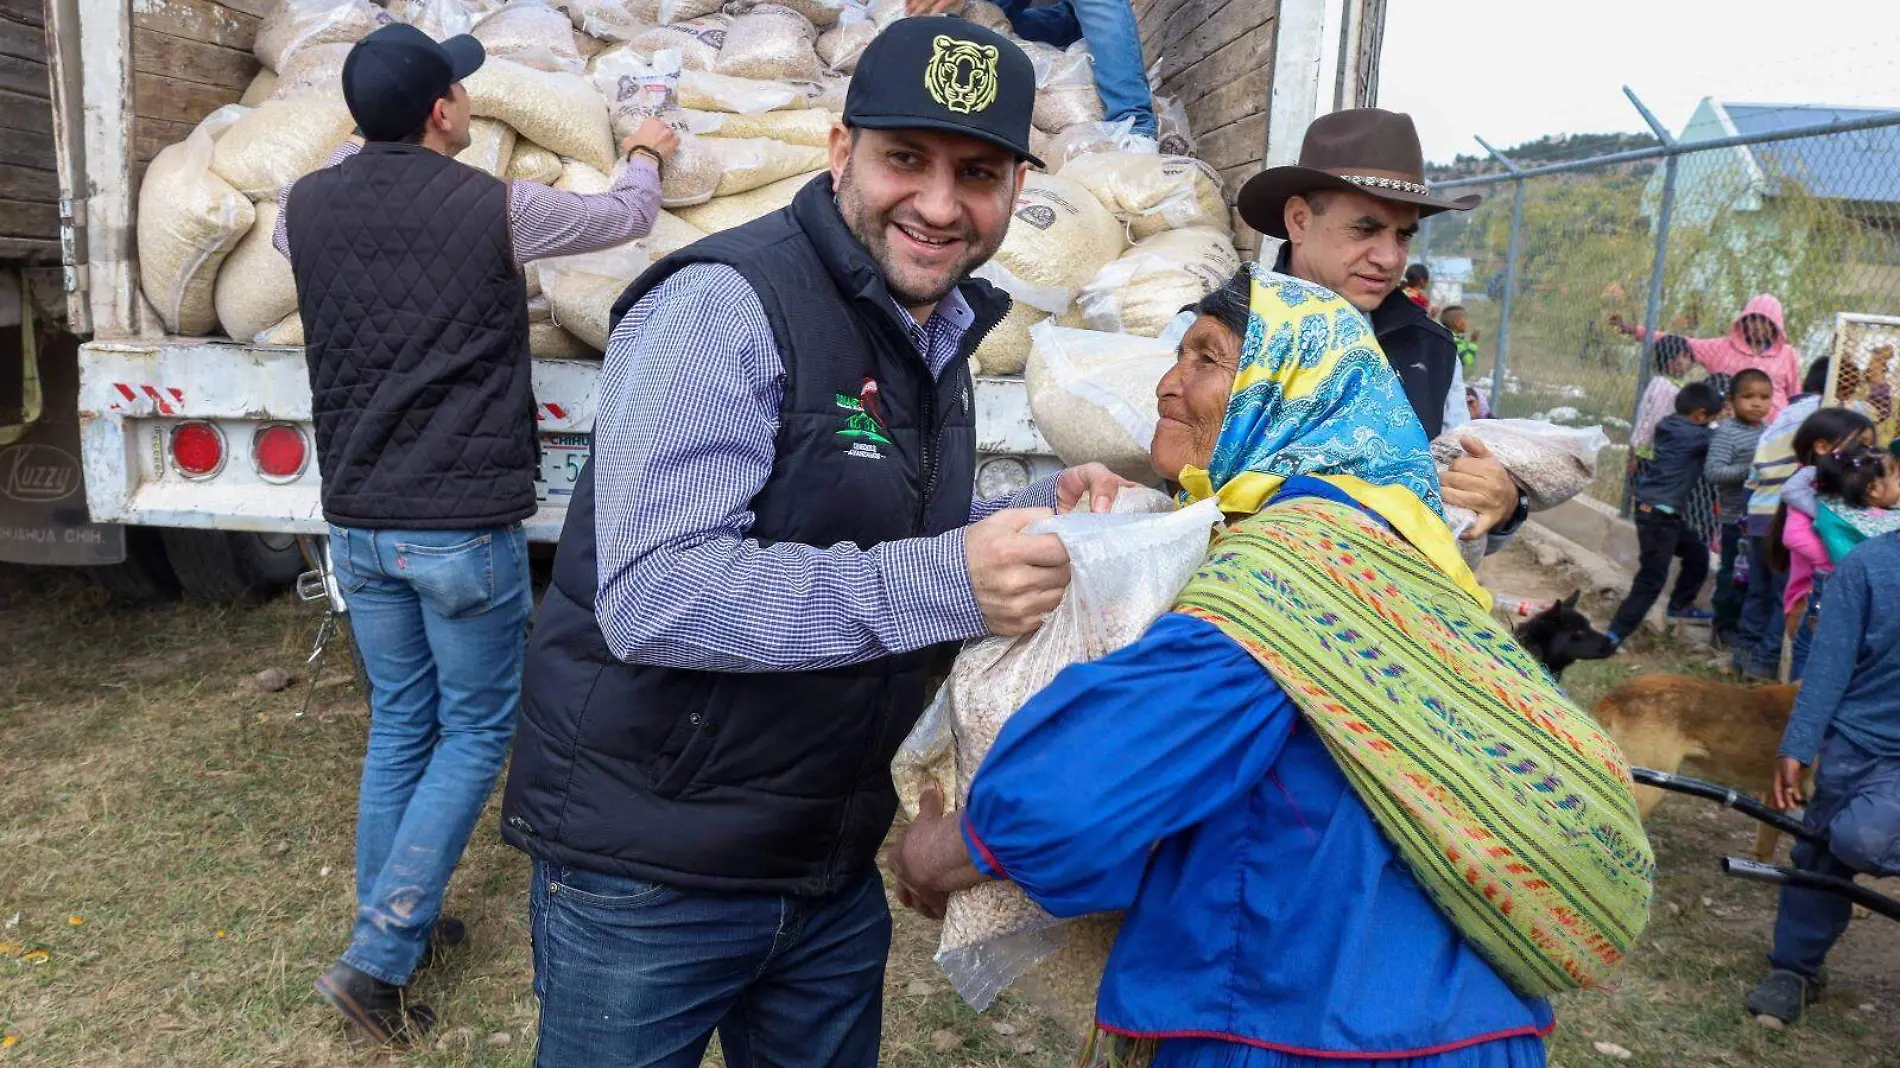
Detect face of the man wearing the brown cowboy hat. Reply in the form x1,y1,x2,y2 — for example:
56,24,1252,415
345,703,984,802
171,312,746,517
1286,190,1419,314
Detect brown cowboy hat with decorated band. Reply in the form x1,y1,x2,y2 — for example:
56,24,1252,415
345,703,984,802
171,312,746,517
1241,108,1484,239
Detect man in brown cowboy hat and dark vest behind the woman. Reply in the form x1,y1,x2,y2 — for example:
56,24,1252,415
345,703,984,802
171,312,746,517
1239,108,1530,547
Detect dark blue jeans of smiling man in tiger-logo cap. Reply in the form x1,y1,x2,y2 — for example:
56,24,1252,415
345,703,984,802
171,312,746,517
528,861,891,1068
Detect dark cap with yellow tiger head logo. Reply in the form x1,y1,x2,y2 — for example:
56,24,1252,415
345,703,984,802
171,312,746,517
844,15,1043,167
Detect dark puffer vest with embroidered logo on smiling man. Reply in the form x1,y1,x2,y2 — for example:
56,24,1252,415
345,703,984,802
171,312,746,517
502,177,1009,895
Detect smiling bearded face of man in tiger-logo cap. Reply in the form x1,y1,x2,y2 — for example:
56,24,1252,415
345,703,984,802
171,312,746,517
830,127,1026,321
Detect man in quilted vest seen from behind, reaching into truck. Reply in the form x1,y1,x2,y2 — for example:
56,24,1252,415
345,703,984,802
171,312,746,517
274,25,673,1041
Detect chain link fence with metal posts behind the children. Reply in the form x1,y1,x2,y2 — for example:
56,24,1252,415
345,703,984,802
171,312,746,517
1416,95,1900,505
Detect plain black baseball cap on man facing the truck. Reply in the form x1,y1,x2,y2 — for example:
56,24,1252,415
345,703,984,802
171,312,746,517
344,23,486,141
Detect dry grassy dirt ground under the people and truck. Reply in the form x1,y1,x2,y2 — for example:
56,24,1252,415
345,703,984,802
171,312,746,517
0,547,1900,1068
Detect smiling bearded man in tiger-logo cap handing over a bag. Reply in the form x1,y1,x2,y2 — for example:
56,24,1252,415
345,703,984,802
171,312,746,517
502,17,1125,1068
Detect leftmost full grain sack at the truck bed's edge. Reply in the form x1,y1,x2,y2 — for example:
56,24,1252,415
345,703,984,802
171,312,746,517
137,105,257,334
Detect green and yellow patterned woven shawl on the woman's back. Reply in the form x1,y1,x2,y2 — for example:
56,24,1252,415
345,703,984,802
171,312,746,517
1176,498,1655,996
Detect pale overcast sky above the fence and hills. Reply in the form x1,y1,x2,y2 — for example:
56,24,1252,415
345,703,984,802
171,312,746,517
1368,0,1900,162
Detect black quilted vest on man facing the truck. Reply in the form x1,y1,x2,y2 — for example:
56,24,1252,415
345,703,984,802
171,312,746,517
285,143,536,530
